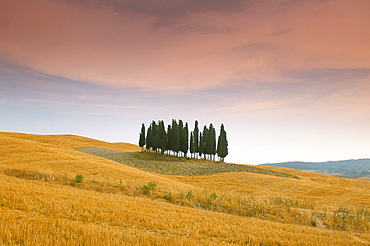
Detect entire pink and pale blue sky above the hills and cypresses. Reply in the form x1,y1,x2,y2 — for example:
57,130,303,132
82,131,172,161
0,0,370,164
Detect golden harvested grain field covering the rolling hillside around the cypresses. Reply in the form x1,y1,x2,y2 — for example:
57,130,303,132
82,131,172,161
0,132,370,246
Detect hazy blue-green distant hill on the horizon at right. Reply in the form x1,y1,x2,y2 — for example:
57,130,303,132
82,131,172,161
260,159,370,175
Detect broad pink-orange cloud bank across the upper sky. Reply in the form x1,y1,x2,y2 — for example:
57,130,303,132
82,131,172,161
0,0,370,90
